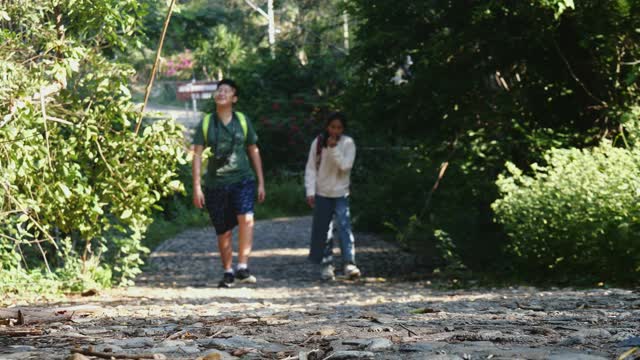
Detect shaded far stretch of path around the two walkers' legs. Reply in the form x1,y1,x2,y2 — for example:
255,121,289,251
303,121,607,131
136,217,424,288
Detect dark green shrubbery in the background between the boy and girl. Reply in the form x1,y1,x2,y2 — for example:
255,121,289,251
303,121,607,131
230,44,351,172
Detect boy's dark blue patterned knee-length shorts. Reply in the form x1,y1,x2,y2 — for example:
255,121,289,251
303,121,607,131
205,179,256,235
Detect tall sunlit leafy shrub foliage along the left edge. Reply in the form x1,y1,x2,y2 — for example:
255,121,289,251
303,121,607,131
0,0,184,296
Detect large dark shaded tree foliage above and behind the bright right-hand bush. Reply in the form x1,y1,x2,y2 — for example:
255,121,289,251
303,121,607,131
341,0,640,269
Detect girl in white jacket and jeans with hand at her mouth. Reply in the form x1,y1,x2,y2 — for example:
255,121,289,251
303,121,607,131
304,113,360,280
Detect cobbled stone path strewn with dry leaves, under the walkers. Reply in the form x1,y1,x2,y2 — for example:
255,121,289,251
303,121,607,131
0,217,640,360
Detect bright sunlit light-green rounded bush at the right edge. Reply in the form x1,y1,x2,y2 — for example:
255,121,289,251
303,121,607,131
492,143,640,281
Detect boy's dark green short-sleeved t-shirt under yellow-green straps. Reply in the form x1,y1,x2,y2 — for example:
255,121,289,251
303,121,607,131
193,112,258,187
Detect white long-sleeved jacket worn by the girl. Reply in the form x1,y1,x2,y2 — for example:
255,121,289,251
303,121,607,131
304,135,356,198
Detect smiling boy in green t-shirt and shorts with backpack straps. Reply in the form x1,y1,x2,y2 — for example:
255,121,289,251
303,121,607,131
192,79,265,288
